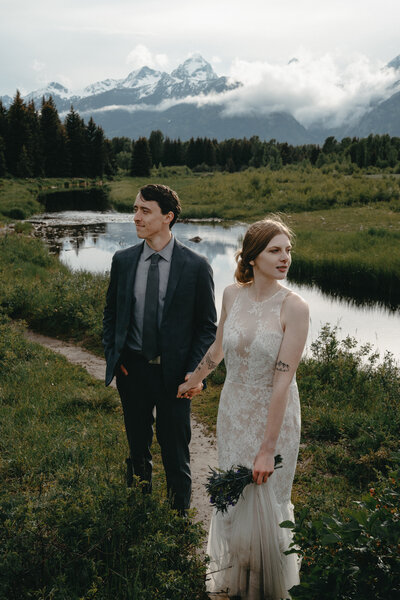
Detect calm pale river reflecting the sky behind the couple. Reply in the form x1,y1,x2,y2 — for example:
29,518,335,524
31,212,400,361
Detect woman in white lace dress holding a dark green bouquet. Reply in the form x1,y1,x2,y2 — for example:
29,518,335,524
178,217,309,600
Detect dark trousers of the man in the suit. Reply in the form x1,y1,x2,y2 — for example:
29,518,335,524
117,352,192,512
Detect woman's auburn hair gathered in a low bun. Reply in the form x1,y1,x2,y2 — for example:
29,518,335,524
235,215,294,285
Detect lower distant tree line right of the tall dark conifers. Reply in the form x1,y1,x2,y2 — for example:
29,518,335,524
111,130,400,177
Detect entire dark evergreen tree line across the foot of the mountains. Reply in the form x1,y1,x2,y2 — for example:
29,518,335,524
0,92,400,178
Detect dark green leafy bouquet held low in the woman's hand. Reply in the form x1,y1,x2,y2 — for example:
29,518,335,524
205,454,282,512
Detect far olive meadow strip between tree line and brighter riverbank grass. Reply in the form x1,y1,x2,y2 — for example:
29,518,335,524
110,167,400,221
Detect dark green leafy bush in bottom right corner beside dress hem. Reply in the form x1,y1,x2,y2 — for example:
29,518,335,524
282,454,400,600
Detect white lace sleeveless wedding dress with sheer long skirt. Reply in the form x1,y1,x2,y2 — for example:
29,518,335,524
207,286,300,600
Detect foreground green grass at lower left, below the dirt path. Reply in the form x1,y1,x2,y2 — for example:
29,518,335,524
0,317,206,600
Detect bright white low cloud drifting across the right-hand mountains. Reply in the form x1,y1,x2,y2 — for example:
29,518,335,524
224,53,400,127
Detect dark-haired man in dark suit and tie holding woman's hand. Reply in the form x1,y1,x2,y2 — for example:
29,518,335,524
103,184,216,513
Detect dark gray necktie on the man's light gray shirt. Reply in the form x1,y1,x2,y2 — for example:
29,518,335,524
142,254,160,360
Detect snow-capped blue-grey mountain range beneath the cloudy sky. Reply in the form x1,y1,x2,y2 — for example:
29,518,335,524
1,54,400,145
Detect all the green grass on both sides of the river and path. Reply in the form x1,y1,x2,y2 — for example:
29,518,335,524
0,169,400,600
